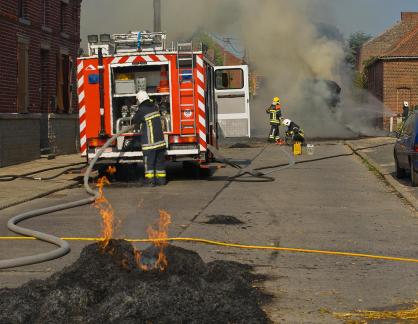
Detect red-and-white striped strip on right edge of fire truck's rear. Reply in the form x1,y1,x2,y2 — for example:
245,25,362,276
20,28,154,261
196,55,207,152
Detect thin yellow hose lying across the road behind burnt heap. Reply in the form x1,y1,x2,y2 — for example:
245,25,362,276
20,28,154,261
0,236,418,263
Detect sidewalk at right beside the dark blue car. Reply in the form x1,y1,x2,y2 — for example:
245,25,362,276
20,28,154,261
346,137,418,210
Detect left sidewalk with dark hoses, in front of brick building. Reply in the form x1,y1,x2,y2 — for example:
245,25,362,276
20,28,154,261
0,154,85,210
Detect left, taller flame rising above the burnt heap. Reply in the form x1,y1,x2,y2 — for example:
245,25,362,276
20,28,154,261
94,177,115,250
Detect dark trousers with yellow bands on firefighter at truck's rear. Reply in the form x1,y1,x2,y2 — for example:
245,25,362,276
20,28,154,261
143,149,167,185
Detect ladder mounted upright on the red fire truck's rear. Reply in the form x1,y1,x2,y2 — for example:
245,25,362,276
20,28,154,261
177,42,197,137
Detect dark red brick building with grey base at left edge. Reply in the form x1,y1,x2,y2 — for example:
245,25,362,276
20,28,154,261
0,0,81,166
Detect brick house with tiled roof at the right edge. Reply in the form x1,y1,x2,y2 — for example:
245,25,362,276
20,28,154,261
359,12,418,129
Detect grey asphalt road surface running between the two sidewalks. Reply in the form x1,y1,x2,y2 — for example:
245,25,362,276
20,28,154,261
0,143,418,323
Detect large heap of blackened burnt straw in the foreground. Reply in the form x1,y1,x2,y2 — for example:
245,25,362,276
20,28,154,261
0,241,269,324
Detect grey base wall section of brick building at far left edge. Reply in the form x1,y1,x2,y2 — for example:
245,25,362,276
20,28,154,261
0,114,41,167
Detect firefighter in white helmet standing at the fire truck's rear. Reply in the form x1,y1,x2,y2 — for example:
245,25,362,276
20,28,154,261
132,91,167,186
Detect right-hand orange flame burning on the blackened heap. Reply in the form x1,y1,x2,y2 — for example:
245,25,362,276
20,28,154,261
135,210,171,271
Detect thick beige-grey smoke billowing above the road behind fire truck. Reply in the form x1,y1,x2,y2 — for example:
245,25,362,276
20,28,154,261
81,0,384,138
